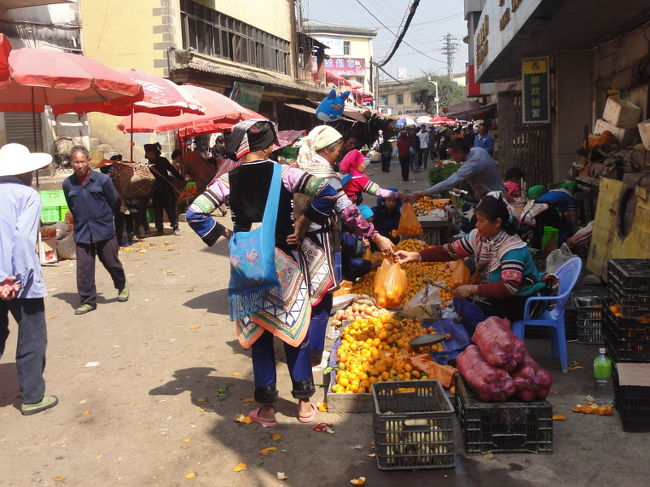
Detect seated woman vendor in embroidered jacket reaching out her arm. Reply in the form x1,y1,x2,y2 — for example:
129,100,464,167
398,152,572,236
396,191,545,332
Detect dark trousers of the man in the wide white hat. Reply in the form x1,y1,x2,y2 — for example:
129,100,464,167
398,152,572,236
0,298,47,404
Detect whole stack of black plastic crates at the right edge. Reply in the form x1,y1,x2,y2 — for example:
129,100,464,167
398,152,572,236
604,259,650,431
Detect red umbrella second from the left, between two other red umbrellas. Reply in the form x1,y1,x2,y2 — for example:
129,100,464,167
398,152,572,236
106,69,204,117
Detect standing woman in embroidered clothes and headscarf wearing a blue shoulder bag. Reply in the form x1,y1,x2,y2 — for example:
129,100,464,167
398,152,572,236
186,119,350,427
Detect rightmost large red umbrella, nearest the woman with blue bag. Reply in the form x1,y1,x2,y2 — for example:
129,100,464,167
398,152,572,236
117,85,264,137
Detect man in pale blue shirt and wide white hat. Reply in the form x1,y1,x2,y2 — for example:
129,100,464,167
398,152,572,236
0,144,59,416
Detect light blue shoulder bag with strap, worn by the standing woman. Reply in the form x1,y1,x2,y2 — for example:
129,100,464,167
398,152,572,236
228,164,282,321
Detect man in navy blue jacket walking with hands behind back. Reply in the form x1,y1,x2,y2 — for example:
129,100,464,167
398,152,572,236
63,145,129,315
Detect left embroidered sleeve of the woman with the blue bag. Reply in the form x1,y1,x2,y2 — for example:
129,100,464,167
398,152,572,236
185,179,230,246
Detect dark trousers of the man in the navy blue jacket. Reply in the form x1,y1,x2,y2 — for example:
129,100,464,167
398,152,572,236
76,238,126,305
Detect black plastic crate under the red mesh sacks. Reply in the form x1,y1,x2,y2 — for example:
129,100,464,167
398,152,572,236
455,374,553,455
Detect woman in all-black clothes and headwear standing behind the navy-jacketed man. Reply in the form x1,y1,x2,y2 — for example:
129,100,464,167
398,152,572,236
144,142,183,235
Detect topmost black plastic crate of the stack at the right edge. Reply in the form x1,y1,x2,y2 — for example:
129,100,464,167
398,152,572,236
607,259,650,316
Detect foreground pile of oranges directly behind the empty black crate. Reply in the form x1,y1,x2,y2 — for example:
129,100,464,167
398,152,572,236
332,314,443,393
